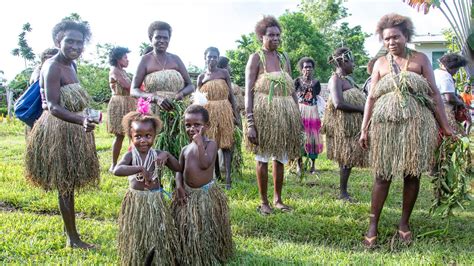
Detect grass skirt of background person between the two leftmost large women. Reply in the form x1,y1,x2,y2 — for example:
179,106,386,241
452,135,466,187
107,95,137,135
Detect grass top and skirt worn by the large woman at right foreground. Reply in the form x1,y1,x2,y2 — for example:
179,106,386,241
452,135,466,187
369,72,438,180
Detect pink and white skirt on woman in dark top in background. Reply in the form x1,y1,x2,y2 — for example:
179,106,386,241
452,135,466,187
299,104,323,159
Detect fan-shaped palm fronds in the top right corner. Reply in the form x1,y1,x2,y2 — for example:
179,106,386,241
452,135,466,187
403,0,474,76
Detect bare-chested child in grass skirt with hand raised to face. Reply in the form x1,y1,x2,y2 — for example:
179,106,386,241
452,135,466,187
172,105,234,265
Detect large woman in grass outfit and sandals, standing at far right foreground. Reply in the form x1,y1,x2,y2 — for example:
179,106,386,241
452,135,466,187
359,14,453,247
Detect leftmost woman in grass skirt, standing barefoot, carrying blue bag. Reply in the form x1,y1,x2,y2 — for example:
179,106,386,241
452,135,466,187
25,20,99,248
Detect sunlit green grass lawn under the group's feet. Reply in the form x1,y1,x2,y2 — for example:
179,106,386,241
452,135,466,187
0,118,474,265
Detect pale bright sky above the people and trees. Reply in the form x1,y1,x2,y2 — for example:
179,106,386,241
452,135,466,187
0,0,449,80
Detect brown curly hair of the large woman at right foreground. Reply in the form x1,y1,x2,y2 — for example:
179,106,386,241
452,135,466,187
375,13,415,42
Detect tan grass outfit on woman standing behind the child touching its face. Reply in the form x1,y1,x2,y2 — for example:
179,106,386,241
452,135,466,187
199,79,234,149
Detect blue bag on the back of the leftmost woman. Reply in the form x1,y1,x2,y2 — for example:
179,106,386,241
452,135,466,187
14,80,43,127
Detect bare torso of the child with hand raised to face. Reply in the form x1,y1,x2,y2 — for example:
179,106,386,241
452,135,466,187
183,140,214,188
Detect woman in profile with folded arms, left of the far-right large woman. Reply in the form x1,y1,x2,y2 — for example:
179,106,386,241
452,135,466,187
322,47,368,201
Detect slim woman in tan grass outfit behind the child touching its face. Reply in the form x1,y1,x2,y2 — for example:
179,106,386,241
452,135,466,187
197,47,240,189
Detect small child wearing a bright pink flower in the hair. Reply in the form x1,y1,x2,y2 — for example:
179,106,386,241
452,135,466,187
113,98,182,265
